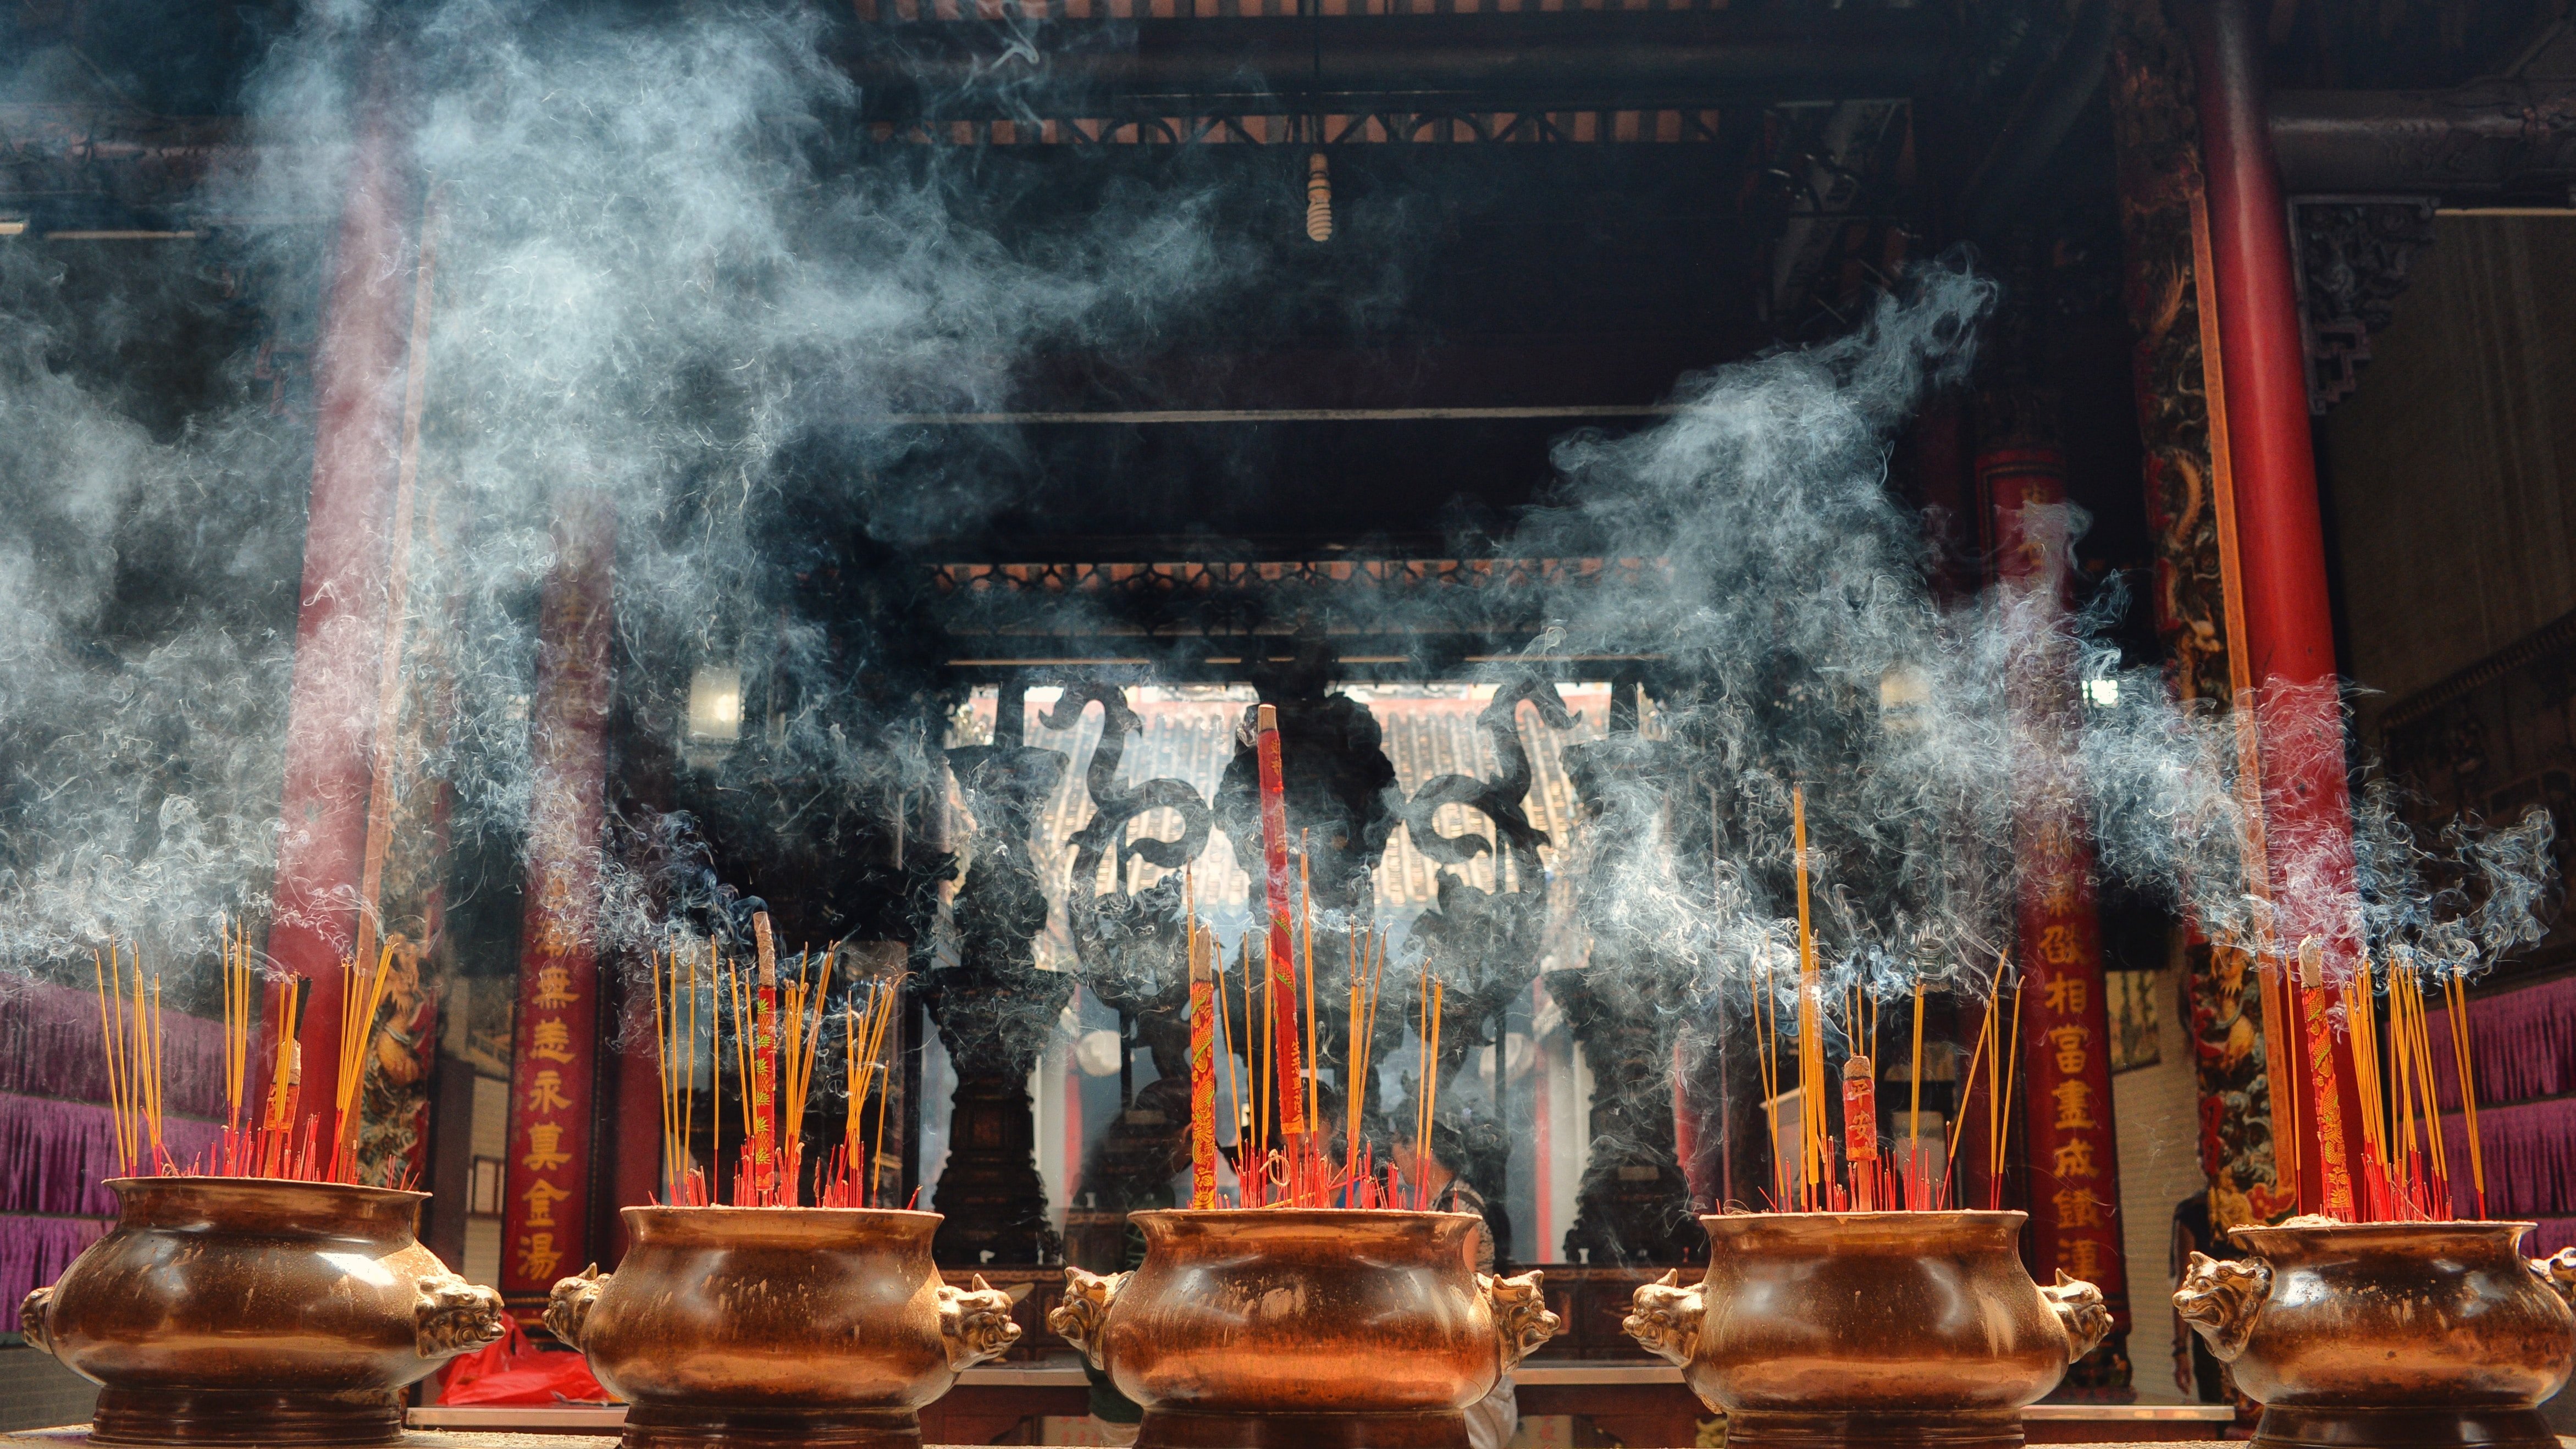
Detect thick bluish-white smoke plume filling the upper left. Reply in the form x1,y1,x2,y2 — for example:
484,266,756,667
0,0,1224,988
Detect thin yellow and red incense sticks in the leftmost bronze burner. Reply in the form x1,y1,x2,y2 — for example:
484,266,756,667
90,921,410,1186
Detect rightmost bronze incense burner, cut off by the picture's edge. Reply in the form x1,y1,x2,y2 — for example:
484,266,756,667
2174,1218,2576,1449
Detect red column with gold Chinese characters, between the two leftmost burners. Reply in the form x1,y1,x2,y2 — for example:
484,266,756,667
500,491,616,1297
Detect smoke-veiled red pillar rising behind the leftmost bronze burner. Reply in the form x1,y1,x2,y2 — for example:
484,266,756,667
268,113,417,1130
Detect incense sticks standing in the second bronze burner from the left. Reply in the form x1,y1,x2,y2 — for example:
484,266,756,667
649,914,902,1207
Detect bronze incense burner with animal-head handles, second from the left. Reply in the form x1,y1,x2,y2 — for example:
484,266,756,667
546,1207,1020,1449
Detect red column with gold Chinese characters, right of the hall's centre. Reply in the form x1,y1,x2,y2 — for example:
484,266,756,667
1976,448,2128,1382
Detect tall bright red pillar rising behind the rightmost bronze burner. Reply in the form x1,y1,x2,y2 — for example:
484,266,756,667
2192,0,2359,1218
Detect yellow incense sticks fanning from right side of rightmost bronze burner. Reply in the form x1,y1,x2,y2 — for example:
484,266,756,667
2339,952,2486,1223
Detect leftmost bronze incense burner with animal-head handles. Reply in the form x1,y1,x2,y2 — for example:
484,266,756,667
18,1176,502,1446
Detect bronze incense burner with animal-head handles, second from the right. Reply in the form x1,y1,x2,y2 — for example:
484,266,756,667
1626,1212,2110,1449
